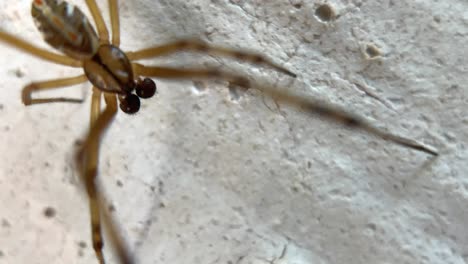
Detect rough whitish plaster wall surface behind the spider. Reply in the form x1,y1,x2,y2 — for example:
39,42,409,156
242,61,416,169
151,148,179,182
0,0,468,264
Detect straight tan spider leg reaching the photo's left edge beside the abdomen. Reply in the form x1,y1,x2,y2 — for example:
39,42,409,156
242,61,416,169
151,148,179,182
0,31,83,67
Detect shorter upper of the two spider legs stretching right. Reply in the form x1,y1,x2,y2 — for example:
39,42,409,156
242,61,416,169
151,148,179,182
126,39,296,77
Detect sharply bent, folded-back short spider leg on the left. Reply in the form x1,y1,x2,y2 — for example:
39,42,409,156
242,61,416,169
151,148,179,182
21,74,88,105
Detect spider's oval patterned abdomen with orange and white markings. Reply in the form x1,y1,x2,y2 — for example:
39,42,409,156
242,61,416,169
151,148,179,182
31,0,99,60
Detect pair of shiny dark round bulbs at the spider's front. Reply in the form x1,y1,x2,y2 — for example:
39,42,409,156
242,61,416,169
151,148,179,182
119,78,156,114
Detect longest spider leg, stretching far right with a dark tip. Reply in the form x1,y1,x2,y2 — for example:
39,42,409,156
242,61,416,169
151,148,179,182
132,63,438,156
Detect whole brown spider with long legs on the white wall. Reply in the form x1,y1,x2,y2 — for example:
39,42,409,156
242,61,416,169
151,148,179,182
0,0,437,264
